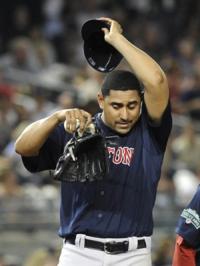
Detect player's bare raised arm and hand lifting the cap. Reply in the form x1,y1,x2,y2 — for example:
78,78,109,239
102,18,169,120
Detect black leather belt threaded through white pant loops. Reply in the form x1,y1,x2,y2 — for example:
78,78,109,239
65,236,146,254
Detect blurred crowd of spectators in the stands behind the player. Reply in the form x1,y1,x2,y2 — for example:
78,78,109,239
0,0,200,266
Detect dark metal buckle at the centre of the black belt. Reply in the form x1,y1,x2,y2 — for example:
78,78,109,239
104,241,129,255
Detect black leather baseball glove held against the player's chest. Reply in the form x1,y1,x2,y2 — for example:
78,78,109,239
53,124,109,182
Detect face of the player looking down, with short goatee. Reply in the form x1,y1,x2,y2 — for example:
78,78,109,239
98,90,141,134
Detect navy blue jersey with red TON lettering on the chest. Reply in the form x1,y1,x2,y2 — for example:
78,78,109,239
23,105,172,237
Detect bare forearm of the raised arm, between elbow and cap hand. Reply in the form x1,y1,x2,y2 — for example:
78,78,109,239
112,34,166,89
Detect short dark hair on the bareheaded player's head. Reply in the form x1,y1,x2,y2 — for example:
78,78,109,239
101,70,143,97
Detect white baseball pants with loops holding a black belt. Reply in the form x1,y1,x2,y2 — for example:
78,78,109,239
58,234,152,266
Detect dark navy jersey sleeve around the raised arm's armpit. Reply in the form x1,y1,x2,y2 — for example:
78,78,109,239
143,101,172,151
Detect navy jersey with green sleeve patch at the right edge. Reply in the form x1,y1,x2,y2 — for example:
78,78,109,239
176,186,200,248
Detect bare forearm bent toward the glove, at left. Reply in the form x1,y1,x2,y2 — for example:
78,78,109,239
15,113,60,156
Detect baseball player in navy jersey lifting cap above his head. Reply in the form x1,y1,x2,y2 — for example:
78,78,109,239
15,18,172,266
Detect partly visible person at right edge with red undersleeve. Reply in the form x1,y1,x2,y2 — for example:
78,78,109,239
173,185,200,266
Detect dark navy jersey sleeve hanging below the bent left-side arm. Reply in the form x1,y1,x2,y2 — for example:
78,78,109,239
22,124,70,172
